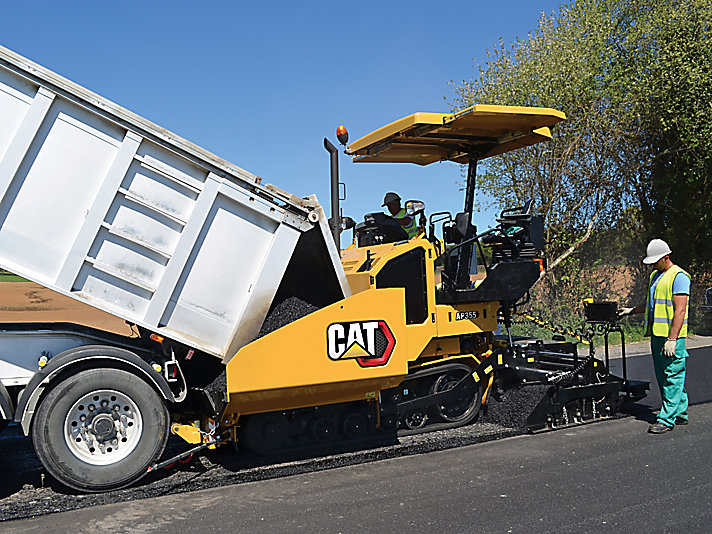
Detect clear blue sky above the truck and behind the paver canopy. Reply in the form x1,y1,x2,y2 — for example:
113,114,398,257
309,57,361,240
0,0,559,247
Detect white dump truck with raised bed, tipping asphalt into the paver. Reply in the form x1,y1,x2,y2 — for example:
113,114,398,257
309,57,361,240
0,48,351,489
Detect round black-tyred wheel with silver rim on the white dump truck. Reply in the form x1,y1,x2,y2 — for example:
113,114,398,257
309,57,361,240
32,369,169,491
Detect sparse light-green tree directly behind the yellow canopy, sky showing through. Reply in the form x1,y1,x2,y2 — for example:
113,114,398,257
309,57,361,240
454,1,631,276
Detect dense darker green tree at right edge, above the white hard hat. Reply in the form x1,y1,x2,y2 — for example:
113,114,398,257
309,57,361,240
612,0,712,270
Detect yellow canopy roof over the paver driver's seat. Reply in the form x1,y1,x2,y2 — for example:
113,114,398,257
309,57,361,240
347,105,566,165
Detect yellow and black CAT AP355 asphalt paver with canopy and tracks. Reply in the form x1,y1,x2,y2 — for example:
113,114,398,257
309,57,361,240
216,105,643,452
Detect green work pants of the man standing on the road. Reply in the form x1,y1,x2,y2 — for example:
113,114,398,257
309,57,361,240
650,336,688,427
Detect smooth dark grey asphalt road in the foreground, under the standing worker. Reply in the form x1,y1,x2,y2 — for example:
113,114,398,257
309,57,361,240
0,347,712,533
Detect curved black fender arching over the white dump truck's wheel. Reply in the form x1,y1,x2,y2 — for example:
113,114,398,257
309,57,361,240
15,345,175,435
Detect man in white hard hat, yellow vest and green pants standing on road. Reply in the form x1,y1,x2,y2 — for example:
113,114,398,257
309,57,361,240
619,239,690,434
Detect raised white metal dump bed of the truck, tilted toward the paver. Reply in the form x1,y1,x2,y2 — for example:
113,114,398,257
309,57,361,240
0,47,350,372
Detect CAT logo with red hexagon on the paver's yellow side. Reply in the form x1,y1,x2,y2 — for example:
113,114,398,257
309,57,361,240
326,321,396,367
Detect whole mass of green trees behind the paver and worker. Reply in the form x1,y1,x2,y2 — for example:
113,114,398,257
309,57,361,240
453,0,712,322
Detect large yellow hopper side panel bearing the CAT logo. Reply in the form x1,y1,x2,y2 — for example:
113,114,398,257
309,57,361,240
227,288,409,414
